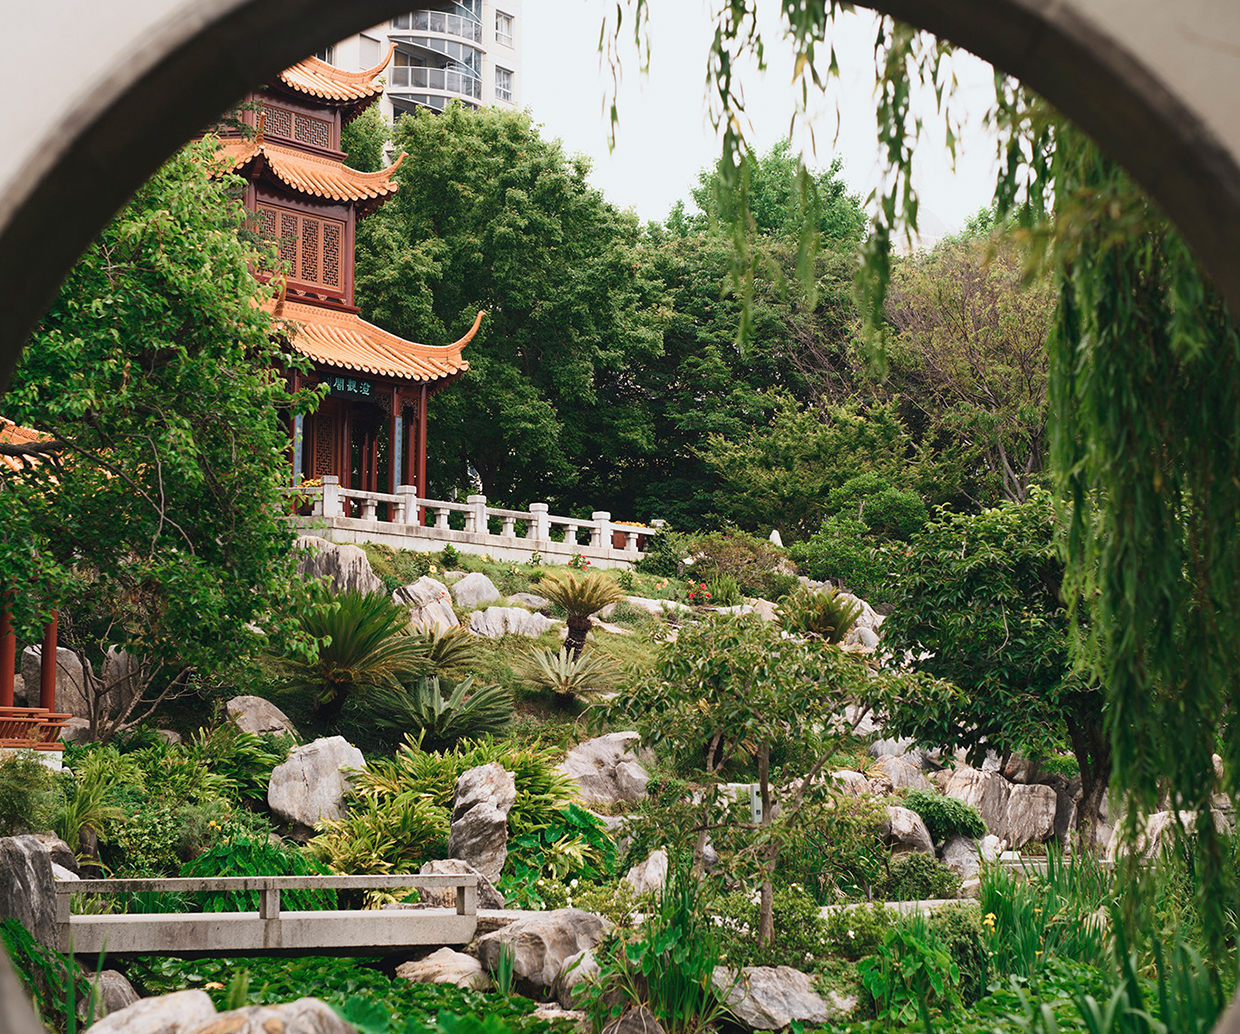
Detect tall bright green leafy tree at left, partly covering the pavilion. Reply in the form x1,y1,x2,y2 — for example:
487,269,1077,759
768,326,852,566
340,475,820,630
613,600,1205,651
0,140,314,736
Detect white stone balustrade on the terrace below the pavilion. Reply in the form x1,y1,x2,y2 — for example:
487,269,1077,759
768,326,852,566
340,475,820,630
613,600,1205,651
284,475,663,567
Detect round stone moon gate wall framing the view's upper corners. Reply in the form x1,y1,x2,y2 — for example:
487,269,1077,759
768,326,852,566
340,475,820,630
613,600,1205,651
0,0,1240,384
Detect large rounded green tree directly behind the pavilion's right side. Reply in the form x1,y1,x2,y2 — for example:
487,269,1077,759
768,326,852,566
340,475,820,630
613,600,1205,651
357,107,663,507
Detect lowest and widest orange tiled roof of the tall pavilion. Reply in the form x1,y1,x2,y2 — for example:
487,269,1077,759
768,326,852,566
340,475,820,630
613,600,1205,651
272,299,482,387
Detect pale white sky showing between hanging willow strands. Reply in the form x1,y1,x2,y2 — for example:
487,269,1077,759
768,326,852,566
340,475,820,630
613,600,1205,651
520,0,997,244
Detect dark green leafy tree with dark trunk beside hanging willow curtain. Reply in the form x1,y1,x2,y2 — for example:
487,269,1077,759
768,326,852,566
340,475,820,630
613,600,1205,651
883,488,1111,843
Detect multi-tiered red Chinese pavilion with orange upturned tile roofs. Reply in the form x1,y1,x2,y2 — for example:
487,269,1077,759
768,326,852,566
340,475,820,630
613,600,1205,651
222,53,482,495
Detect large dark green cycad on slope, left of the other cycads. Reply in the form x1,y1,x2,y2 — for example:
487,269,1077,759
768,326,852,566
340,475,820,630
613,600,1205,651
283,590,430,722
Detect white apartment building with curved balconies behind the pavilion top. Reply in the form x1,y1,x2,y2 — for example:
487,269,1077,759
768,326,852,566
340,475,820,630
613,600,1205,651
317,0,522,123
